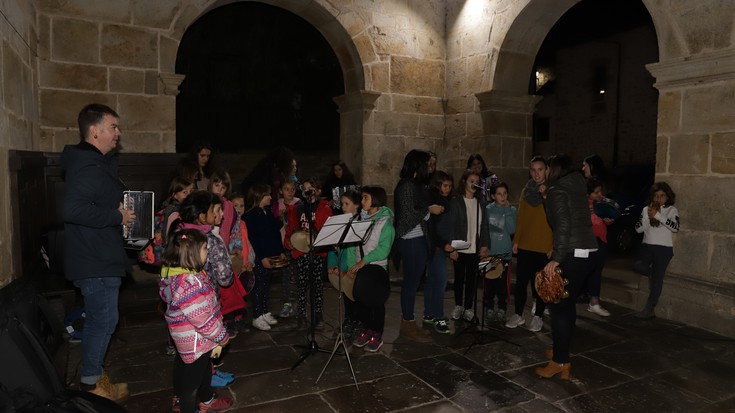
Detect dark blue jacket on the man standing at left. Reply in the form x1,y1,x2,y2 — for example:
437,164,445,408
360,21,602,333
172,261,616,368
61,142,130,280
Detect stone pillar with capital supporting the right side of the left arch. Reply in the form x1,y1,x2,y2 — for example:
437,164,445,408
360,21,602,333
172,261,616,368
334,90,380,182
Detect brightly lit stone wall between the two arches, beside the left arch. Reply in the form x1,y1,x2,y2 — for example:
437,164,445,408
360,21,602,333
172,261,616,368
344,0,446,187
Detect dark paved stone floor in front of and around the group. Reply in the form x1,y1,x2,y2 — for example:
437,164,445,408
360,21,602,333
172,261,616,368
70,268,735,413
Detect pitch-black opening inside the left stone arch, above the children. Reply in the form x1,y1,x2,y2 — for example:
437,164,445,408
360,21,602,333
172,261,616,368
176,2,344,154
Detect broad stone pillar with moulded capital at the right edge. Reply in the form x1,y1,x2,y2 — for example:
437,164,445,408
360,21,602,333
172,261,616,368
641,49,735,336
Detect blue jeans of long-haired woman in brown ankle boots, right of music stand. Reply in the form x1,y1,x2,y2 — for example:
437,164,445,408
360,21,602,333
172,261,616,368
398,236,429,320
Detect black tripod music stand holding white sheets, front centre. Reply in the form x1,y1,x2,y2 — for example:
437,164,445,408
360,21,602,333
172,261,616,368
314,214,373,390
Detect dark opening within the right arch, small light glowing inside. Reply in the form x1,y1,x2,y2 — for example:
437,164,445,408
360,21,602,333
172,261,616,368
529,0,658,253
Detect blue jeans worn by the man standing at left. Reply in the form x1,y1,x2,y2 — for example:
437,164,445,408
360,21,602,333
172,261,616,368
74,277,122,385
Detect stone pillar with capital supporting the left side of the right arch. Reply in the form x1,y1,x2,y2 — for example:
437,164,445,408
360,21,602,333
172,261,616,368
475,90,541,193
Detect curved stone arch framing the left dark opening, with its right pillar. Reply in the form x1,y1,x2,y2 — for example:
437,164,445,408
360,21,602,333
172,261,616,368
161,0,379,176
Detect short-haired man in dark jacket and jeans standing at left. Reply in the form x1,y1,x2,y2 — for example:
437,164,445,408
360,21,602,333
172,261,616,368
61,104,135,400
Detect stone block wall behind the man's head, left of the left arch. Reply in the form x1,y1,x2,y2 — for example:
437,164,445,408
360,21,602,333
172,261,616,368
37,0,178,152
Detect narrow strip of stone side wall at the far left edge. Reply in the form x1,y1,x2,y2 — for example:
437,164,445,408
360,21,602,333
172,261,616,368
0,0,39,287
